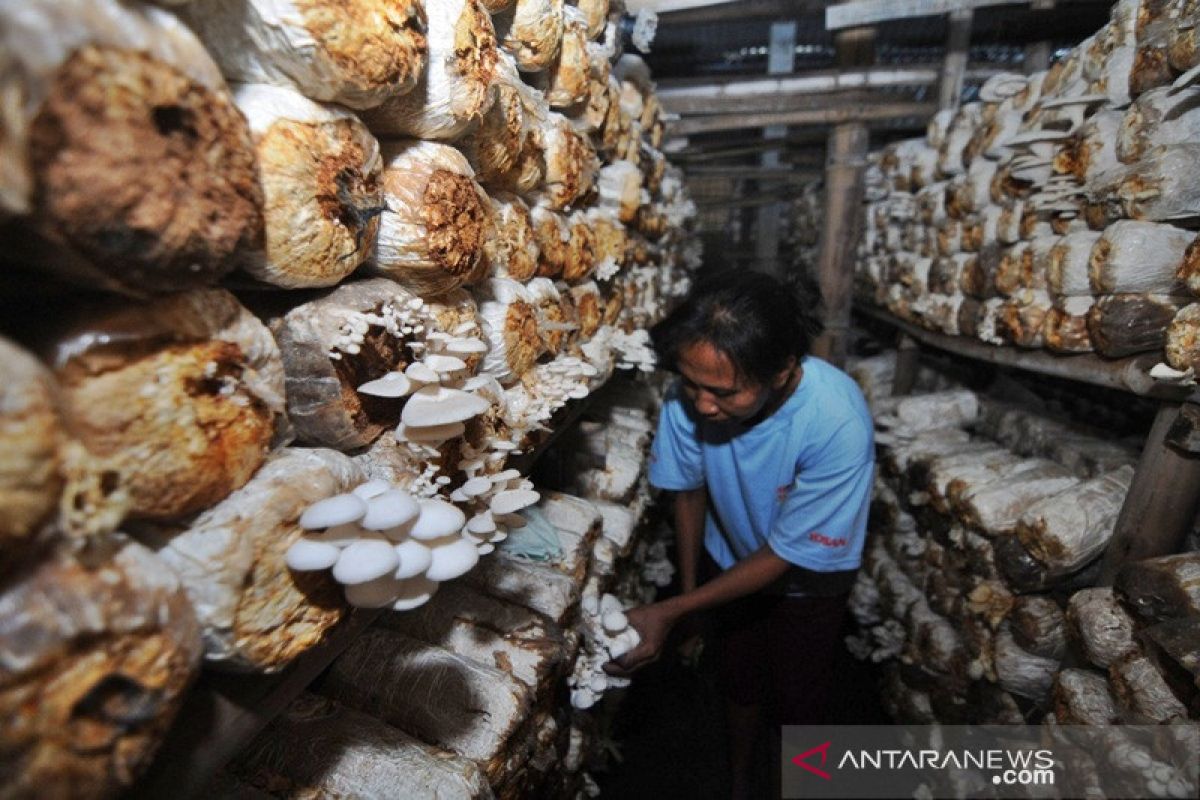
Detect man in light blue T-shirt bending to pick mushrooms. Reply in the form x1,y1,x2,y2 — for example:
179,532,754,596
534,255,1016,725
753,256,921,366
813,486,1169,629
607,272,874,796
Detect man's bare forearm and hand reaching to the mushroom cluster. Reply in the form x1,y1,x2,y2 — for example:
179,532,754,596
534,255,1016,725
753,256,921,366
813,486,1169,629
605,545,792,675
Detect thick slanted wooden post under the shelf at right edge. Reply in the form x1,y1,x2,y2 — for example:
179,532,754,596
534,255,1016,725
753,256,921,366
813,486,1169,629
1100,403,1200,585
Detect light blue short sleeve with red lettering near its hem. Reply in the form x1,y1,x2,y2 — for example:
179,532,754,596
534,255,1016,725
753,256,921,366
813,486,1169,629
767,422,875,572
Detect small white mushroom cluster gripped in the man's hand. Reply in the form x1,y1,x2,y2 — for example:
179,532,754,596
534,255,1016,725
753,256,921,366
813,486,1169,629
566,585,642,710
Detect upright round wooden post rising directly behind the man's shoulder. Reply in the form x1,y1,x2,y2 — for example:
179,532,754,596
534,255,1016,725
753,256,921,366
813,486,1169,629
812,21,875,367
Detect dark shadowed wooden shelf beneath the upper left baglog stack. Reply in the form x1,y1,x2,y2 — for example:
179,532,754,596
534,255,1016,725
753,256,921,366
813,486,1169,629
128,372,618,800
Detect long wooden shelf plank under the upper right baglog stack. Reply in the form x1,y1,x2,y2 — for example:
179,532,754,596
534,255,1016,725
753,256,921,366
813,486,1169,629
854,303,1195,401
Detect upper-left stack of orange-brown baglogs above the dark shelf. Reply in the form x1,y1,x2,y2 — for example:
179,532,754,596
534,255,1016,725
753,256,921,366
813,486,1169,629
0,0,694,796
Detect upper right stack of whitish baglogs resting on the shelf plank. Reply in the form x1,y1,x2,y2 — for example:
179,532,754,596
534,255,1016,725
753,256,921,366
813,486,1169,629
857,0,1200,377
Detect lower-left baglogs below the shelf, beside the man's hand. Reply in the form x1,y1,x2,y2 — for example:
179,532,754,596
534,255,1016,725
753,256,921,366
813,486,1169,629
210,379,659,798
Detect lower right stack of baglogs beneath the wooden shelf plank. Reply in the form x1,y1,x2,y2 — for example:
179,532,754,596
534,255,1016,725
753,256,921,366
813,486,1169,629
851,371,1200,796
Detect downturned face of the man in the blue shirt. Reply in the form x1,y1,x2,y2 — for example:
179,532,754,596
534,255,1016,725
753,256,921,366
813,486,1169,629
677,341,786,422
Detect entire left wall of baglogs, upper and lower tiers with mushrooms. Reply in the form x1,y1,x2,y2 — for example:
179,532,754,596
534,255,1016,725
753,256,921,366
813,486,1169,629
0,0,697,798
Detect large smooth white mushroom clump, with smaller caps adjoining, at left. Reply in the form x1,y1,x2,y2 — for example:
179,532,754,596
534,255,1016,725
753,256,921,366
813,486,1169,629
286,470,539,610
